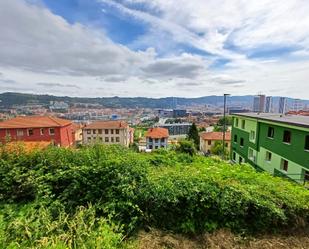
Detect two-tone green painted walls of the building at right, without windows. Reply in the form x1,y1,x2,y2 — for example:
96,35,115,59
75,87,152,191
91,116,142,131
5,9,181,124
231,115,309,182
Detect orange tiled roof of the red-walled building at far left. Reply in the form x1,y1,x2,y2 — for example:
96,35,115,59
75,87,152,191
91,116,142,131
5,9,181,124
0,116,72,129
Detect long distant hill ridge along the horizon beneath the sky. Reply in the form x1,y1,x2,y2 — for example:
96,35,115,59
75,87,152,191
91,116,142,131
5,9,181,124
0,92,309,108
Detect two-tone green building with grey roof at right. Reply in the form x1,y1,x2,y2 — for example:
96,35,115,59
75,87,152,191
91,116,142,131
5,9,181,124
231,113,309,183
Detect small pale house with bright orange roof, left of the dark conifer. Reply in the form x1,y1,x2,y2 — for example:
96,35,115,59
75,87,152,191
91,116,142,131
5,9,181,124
145,127,169,150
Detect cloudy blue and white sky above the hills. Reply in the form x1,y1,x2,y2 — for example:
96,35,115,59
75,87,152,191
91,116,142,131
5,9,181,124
0,0,309,99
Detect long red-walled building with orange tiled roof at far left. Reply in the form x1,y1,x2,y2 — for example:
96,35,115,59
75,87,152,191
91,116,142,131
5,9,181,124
0,116,74,147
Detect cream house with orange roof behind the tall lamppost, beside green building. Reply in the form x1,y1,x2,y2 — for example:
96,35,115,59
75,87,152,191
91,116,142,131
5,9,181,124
200,131,231,154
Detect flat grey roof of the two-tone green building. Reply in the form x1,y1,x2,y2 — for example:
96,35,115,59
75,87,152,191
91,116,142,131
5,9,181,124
233,113,309,128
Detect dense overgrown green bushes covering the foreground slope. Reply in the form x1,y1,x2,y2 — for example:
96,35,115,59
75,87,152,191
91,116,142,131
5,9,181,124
0,145,309,248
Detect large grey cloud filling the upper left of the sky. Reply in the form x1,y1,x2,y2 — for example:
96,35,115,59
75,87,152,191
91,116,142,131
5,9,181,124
0,0,147,76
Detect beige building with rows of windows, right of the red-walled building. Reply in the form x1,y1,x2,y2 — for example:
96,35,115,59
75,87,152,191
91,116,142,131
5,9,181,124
83,121,133,147
